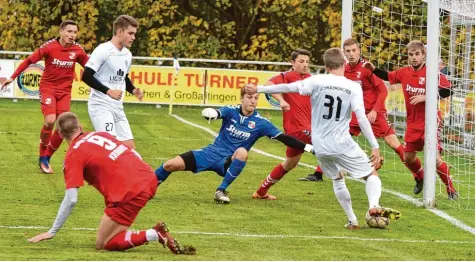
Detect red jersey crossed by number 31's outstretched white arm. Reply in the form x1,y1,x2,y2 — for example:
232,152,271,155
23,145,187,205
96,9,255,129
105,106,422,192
269,70,311,134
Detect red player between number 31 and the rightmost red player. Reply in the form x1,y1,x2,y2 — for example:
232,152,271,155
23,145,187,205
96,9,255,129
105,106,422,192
302,38,422,194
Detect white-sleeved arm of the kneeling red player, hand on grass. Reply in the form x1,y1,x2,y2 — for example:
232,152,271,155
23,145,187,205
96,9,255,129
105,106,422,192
28,188,78,243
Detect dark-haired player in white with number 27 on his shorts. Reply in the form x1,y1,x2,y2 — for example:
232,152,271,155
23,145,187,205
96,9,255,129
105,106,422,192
82,15,143,148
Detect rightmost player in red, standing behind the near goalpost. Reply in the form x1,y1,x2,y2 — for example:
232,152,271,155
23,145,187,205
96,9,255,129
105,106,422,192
365,40,458,200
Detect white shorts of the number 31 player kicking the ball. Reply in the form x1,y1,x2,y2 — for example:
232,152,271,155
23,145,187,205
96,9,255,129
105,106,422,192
316,145,374,179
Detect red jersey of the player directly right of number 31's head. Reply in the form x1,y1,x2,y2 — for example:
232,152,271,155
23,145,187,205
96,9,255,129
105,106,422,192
344,59,388,113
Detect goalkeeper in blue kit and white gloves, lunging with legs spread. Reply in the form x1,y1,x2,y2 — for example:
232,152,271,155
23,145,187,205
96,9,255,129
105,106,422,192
155,88,312,204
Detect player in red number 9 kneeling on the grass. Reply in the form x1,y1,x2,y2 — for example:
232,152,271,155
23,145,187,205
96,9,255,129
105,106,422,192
28,112,195,254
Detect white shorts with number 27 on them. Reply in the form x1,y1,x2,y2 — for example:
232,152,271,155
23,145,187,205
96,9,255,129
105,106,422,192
88,101,134,141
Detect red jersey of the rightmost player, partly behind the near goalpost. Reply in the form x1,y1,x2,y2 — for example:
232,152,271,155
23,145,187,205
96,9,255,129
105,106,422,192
388,66,451,129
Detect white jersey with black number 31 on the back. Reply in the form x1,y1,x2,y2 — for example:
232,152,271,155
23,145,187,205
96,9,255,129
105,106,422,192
298,74,365,154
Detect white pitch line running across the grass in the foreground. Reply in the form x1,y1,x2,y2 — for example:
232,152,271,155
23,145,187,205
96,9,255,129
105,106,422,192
0,226,475,245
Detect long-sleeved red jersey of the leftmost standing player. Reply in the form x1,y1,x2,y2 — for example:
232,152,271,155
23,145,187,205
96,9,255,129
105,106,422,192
11,38,88,94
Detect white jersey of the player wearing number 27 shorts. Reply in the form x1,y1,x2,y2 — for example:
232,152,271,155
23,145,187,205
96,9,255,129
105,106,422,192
86,41,132,109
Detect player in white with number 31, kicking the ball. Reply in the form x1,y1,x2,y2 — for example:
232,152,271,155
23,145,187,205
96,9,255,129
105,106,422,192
245,48,400,229
